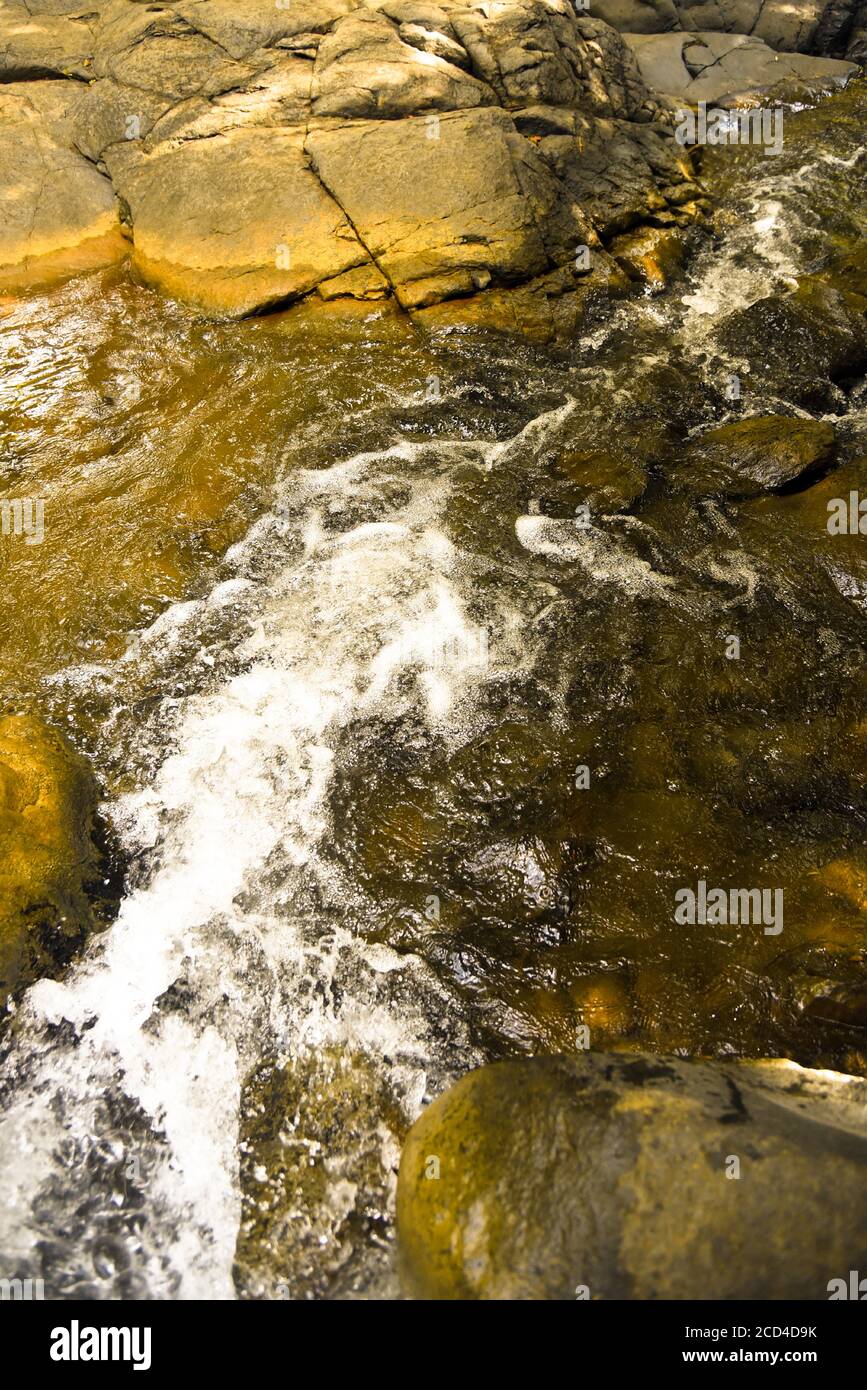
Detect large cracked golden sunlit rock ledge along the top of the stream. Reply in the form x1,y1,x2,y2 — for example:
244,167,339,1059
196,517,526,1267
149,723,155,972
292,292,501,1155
0,0,854,336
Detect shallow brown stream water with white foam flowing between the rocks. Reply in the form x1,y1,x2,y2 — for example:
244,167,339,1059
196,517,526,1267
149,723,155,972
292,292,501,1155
0,89,867,1298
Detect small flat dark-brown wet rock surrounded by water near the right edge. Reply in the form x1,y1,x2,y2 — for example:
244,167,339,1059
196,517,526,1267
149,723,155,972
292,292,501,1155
678,416,836,498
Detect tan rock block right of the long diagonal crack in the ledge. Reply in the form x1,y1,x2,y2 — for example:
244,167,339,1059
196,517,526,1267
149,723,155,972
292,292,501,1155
307,110,593,309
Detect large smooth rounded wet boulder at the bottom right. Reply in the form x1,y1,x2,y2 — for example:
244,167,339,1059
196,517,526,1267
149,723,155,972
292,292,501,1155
397,1054,867,1300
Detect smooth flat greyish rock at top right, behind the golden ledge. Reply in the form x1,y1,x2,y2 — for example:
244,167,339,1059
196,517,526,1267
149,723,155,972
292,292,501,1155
627,31,857,106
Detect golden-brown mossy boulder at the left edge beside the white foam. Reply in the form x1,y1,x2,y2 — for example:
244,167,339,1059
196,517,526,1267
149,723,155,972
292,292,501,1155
0,714,101,1002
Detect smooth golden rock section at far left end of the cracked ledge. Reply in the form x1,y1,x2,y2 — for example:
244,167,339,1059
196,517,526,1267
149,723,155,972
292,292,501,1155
0,82,126,288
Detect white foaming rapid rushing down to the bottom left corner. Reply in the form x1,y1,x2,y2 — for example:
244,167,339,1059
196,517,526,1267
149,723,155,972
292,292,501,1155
1,445,518,1298
